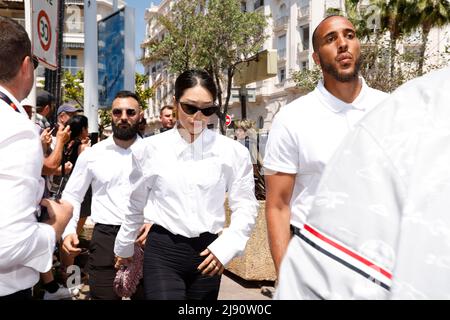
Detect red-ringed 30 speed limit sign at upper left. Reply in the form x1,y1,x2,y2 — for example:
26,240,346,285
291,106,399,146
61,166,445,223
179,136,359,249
31,1,59,69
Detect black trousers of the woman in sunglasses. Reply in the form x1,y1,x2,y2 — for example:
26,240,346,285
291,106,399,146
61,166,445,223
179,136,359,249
144,225,221,300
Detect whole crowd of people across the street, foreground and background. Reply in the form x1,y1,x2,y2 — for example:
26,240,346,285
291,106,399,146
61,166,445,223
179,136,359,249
0,16,450,300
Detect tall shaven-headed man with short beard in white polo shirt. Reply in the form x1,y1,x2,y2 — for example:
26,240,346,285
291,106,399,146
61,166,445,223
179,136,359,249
264,16,387,292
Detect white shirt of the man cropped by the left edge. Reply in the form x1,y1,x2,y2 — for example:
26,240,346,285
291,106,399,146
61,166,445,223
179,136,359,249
0,87,55,296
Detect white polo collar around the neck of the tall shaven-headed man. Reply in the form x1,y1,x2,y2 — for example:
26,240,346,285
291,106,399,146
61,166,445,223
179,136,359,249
315,77,368,113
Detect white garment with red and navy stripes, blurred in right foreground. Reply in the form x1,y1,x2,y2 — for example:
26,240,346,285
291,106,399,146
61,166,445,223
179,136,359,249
277,68,450,299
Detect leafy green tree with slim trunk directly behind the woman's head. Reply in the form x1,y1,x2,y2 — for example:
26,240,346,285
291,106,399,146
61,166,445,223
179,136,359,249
144,0,267,133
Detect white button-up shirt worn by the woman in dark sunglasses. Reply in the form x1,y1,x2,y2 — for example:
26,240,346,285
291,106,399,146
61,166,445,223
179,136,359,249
115,129,258,264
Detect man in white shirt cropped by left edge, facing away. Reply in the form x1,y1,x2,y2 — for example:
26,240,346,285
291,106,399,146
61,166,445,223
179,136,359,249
0,17,71,300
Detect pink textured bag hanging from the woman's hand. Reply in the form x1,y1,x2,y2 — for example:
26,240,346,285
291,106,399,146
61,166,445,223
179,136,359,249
114,244,144,298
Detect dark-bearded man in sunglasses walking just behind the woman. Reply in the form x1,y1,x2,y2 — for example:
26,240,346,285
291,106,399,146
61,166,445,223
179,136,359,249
62,91,149,300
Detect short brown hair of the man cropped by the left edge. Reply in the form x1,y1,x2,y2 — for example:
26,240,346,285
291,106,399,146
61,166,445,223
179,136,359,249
0,16,31,82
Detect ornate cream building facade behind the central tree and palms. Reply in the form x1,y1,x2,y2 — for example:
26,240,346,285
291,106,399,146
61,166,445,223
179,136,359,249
141,0,450,131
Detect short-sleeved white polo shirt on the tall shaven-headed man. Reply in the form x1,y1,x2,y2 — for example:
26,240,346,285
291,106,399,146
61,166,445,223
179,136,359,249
264,78,388,228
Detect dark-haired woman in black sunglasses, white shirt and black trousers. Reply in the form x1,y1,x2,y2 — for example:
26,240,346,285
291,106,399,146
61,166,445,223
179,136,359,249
114,70,258,300
